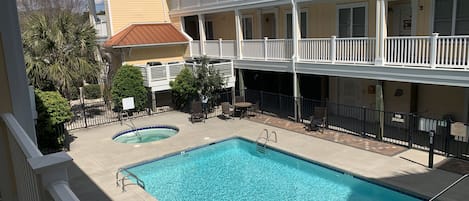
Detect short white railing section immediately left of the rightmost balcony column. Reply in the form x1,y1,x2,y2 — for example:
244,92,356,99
335,38,376,63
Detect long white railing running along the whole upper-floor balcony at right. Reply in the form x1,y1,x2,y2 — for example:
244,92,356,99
191,34,469,70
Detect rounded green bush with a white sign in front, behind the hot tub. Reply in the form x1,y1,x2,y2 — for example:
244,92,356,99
111,65,147,111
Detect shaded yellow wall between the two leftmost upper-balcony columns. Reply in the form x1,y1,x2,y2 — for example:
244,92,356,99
205,12,236,40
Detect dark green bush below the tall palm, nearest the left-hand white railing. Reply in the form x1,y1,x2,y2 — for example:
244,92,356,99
35,90,72,152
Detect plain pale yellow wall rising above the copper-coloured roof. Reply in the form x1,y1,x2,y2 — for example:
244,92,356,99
105,0,169,35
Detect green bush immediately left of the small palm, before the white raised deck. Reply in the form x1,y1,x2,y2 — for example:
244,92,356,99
169,68,198,109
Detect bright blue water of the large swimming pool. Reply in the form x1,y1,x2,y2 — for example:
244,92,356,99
128,138,419,201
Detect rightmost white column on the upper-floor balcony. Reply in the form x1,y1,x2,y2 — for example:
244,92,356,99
375,0,388,66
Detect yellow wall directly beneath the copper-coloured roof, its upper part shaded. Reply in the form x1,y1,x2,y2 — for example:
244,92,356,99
123,45,187,64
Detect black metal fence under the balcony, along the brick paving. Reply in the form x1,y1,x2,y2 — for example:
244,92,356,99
241,90,469,160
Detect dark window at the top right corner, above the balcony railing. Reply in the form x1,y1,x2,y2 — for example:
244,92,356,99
433,0,469,36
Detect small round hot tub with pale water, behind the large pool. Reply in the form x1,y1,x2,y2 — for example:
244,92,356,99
112,126,179,144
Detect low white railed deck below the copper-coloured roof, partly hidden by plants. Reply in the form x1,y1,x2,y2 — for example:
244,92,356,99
137,61,235,91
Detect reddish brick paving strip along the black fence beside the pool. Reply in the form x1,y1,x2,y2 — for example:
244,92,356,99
248,114,407,156
